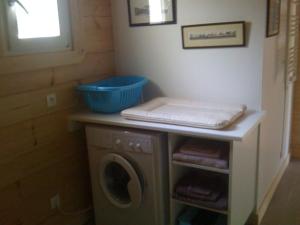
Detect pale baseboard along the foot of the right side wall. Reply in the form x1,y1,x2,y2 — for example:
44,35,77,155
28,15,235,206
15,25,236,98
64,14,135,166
255,154,291,224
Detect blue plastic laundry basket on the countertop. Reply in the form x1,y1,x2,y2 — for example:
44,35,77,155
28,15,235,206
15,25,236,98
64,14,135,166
77,76,147,113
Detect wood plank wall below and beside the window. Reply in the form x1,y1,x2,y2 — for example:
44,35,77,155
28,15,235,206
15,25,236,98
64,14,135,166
0,0,114,225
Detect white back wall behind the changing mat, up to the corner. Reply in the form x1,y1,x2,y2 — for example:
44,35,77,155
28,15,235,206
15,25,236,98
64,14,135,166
112,0,265,109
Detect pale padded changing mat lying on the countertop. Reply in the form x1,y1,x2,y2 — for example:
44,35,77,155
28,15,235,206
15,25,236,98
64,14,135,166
121,97,246,129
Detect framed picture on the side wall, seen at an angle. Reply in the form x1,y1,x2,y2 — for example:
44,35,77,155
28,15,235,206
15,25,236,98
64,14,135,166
266,0,281,37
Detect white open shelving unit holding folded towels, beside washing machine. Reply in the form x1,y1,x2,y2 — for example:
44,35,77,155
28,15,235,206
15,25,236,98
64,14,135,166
168,131,257,225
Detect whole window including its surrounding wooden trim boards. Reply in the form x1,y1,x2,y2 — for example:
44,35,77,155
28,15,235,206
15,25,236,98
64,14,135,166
0,0,86,76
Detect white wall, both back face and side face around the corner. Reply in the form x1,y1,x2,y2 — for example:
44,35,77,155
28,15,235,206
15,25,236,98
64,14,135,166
112,0,287,211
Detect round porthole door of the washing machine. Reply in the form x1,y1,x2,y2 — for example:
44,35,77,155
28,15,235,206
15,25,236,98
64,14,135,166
99,153,143,209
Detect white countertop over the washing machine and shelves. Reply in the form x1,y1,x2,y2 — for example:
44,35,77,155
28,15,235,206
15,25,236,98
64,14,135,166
69,111,265,141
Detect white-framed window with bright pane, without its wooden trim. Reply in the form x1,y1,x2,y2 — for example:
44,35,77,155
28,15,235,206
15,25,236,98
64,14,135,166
4,0,72,54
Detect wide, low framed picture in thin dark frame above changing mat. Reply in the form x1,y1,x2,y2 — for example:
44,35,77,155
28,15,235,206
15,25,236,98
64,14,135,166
182,21,246,49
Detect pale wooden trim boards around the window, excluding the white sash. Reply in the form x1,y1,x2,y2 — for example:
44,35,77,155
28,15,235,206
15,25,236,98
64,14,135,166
0,0,86,76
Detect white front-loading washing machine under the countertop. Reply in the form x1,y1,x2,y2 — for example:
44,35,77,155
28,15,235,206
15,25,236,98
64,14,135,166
86,125,169,225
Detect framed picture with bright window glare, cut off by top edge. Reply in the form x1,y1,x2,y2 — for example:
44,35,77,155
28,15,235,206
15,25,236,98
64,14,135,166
127,0,176,26
